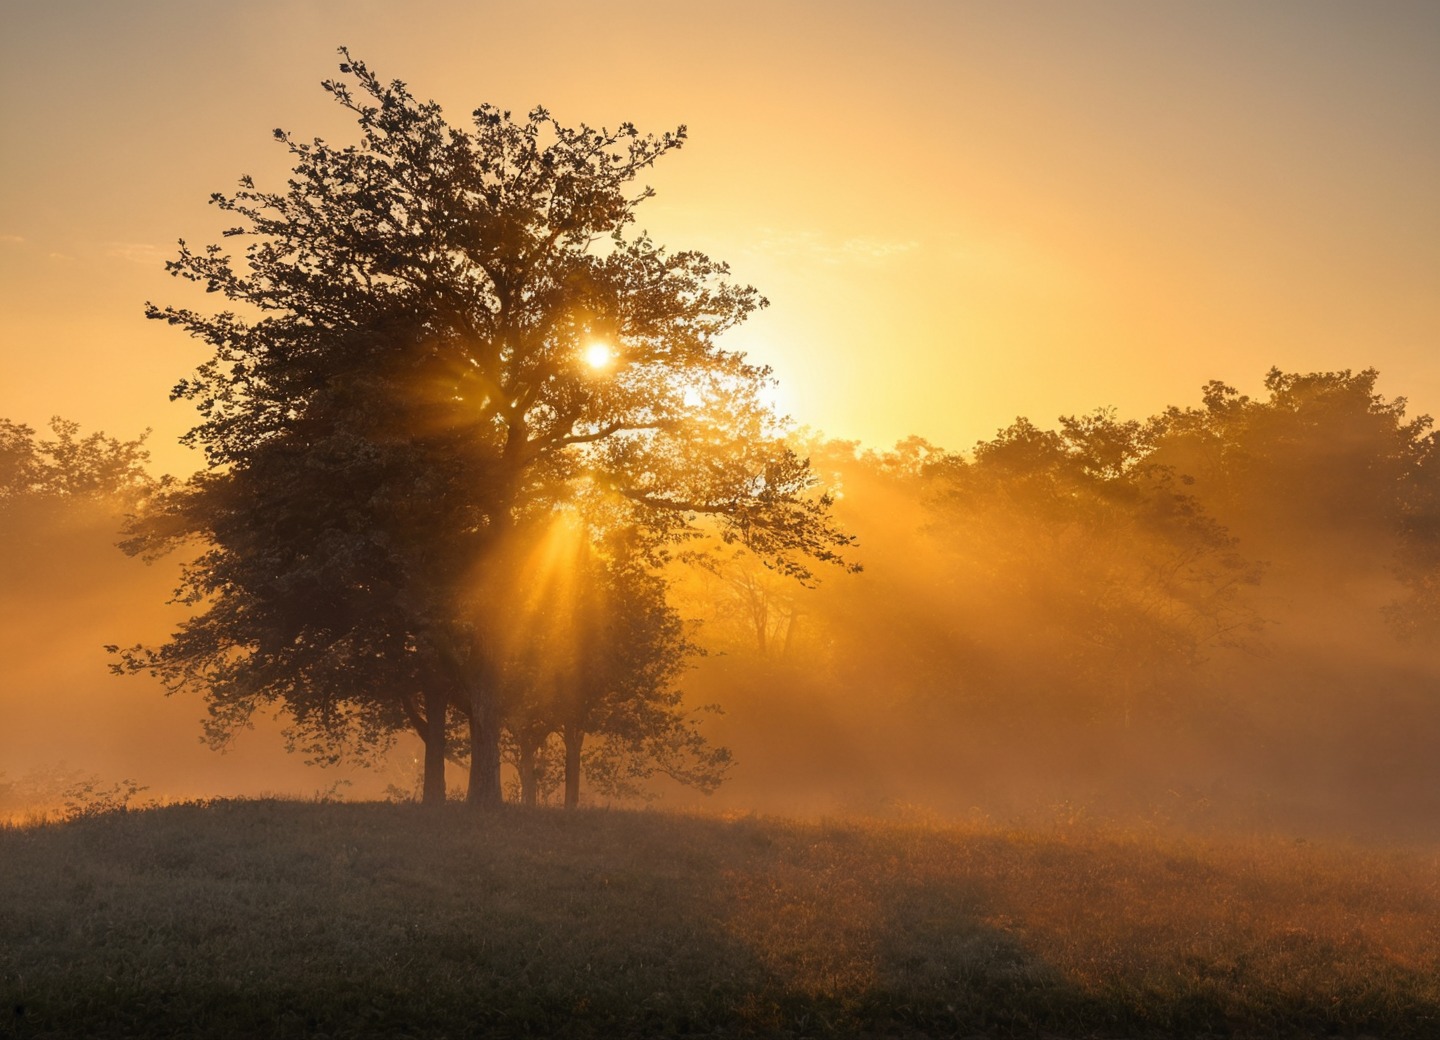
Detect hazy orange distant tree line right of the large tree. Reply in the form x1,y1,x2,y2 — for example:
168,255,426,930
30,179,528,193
677,370,1440,815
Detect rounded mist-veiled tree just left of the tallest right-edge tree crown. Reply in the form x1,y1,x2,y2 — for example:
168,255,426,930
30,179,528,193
933,412,1260,720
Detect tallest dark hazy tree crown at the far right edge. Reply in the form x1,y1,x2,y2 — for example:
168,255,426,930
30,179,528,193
1158,369,1440,638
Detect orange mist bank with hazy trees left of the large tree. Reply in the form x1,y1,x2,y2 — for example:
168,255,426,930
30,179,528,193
0,421,412,820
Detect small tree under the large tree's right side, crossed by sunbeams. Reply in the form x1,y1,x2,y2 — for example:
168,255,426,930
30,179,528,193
484,503,729,808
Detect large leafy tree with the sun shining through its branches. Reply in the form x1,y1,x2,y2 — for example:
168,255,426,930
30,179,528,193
122,50,848,804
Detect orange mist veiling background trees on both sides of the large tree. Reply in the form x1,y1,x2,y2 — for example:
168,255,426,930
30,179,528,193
0,372,1440,838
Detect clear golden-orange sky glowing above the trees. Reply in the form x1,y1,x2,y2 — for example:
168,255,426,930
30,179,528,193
0,0,1440,470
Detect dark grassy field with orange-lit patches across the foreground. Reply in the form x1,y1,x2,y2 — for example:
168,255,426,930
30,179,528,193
0,801,1440,1039
